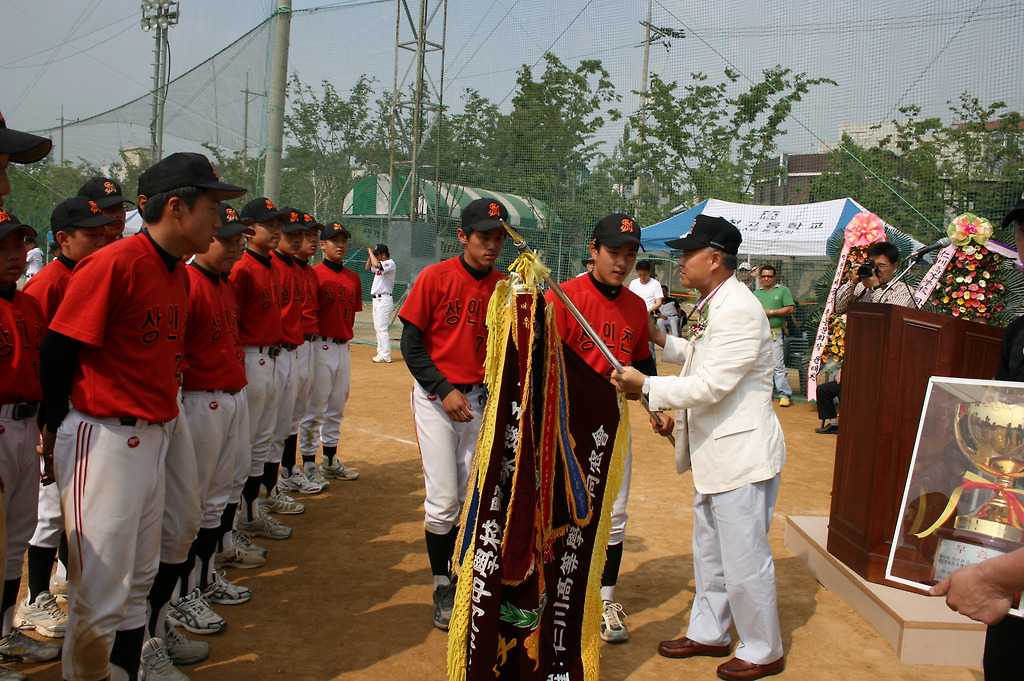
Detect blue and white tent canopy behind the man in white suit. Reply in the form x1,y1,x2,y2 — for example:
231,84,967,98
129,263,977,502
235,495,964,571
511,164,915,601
640,199,923,258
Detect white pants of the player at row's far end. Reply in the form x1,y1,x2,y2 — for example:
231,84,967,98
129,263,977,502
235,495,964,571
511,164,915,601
299,339,352,457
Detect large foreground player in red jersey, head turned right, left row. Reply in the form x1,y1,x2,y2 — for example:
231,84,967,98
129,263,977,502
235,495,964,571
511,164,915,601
41,154,245,681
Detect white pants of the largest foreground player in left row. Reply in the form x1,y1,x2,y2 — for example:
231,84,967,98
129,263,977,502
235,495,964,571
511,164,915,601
53,409,168,681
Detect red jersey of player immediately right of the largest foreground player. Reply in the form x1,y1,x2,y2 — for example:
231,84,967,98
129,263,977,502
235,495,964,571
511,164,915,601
181,263,248,390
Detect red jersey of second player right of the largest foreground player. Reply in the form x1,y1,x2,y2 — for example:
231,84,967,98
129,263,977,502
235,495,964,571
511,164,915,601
228,250,285,346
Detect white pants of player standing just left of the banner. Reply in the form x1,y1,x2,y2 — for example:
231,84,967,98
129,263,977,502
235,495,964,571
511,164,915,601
412,382,487,535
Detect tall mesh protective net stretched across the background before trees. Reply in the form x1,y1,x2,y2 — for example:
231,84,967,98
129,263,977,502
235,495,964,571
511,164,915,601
10,0,1024,368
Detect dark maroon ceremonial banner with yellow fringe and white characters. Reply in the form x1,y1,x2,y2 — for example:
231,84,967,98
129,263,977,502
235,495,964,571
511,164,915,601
449,282,629,681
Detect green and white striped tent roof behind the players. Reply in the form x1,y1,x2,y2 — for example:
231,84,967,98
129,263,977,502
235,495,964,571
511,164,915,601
342,173,561,229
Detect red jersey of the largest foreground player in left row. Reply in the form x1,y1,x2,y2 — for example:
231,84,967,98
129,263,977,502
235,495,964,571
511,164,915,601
50,232,188,422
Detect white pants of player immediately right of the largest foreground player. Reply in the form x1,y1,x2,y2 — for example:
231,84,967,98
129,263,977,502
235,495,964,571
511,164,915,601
182,390,249,529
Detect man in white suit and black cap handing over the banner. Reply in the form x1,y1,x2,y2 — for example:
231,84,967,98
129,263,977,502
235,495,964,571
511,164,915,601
612,215,785,681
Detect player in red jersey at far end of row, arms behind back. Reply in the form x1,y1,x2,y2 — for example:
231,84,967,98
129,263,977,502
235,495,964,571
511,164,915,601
299,222,362,480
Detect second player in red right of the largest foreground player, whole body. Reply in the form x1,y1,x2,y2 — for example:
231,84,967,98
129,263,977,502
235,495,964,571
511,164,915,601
228,197,292,540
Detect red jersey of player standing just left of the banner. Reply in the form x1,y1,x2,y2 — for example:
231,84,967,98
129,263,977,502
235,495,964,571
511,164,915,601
398,257,507,383
